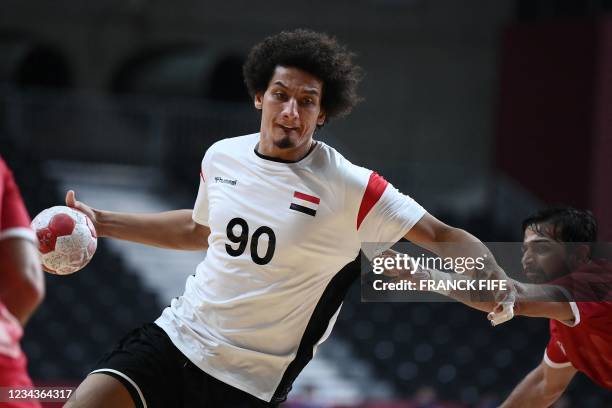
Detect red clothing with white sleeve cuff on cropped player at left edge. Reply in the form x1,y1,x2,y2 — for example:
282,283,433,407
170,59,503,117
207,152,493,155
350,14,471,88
0,157,40,408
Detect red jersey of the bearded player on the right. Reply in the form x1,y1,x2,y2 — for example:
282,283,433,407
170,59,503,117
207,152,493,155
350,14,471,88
544,262,612,389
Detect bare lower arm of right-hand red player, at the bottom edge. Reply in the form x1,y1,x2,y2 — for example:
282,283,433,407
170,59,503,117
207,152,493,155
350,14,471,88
500,361,576,408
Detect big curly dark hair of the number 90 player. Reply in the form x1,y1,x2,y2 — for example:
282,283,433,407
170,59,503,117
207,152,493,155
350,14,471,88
242,29,363,121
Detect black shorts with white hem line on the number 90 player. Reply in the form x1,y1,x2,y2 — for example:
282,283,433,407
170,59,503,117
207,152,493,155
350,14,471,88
91,323,275,408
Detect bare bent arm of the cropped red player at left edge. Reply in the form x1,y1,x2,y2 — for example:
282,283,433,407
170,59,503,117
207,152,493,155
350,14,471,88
0,238,45,326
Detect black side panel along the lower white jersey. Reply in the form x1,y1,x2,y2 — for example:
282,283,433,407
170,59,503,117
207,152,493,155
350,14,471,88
270,257,360,404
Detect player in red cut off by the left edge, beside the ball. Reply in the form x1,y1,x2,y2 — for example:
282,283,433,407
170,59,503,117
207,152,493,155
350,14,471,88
0,157,44,408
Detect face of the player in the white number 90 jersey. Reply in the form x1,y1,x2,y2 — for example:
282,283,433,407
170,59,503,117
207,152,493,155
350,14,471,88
255,66,325,149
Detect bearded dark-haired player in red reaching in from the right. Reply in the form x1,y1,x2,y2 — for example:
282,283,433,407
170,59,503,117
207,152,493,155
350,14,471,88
502,208,612,407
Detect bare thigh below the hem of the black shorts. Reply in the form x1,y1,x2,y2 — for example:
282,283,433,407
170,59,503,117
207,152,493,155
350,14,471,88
64,373,135,408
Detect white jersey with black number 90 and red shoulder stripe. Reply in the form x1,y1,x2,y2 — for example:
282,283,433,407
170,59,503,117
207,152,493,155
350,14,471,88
156,134,425,401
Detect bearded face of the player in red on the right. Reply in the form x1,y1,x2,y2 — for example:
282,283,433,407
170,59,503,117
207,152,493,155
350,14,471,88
522,224,569,283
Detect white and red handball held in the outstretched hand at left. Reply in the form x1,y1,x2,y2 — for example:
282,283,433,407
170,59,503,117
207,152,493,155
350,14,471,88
32,206,98,275
